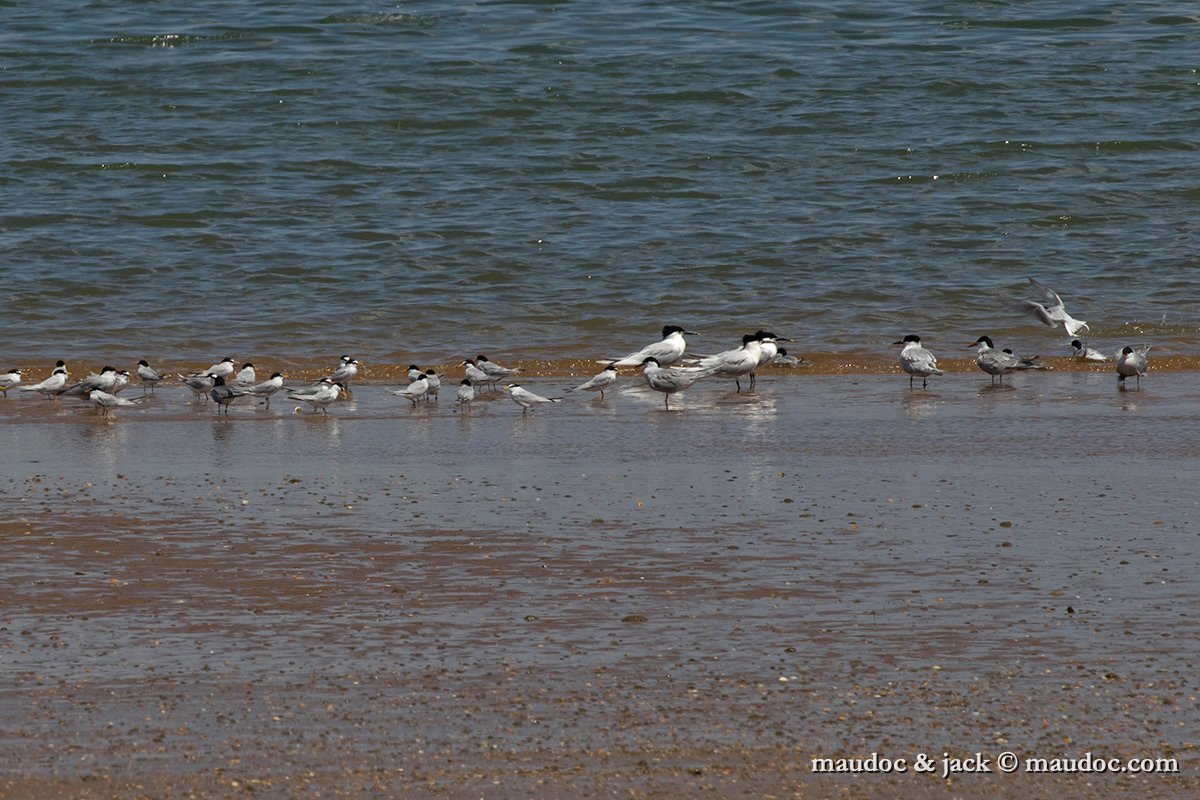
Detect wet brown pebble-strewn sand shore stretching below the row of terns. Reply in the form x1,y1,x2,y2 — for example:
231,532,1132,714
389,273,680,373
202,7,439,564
0,362,1200,798
